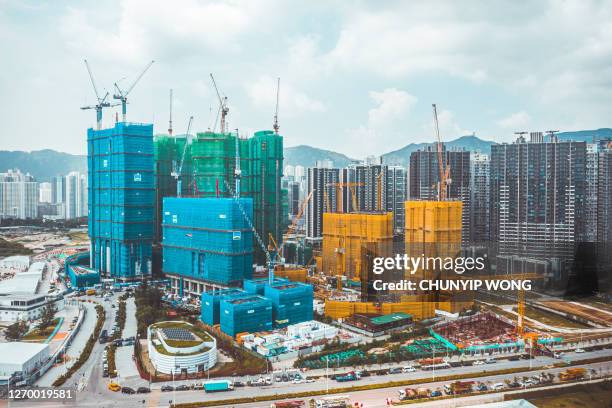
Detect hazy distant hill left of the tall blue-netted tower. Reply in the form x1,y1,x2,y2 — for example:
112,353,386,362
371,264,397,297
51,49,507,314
0,149,87,182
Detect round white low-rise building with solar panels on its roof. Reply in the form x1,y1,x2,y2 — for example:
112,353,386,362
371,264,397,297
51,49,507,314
147,321,217,374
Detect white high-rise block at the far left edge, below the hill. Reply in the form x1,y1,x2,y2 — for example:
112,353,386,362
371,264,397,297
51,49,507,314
0,169,38,219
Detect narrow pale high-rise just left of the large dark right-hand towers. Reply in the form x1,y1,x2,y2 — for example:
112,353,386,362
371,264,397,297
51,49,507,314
469,152,491,244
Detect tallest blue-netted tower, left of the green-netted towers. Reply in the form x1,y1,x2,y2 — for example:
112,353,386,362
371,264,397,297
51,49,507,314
87,122,155,278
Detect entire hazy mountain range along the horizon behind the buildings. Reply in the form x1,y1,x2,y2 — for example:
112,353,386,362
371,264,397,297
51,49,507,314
0,128,612,181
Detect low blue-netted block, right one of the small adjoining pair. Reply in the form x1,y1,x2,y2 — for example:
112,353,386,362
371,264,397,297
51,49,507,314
264,282,313,327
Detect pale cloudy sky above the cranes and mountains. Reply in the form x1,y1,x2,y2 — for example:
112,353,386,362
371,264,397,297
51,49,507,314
0,0,612,158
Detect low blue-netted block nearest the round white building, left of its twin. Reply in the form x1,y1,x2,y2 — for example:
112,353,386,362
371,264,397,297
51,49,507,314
219,295,272,336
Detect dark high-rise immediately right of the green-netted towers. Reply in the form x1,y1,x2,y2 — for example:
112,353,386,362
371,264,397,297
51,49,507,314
306,162,340,240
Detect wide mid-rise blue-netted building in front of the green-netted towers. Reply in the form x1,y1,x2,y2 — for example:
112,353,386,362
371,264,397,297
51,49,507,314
162,197,253,285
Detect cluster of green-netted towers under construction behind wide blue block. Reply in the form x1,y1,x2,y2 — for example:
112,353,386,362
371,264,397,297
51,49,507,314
155,130,288,263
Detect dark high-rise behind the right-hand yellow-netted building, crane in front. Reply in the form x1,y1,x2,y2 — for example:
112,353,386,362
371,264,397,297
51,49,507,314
409,146,471,242
